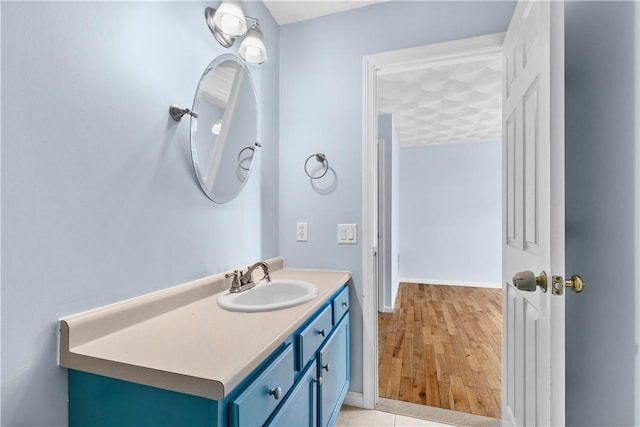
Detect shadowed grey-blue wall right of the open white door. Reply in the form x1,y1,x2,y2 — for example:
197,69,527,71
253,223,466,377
565,2,640,426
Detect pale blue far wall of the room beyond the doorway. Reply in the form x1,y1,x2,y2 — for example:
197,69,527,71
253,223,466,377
400,141,502,286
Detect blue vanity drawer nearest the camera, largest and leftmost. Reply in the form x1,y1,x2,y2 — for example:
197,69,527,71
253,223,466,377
229,344,293,426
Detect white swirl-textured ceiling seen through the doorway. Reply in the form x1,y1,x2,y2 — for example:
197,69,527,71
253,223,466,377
378,57,502,147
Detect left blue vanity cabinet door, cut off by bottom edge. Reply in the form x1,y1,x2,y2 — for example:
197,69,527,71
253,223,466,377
267,362,318,427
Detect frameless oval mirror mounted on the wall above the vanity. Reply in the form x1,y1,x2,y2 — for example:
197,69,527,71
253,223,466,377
191,54,259,203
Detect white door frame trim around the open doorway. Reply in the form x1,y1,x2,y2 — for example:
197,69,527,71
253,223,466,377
361,33,505,409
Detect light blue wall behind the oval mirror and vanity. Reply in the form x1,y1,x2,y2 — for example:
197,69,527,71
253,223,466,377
1,1,279,426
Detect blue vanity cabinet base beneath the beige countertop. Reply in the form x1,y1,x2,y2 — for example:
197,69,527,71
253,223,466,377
69,285,349,427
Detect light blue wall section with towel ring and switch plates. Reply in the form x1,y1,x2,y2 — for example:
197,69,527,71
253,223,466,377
280,1,514,392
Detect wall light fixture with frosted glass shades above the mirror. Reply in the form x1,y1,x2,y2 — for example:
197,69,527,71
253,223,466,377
204,0,267,65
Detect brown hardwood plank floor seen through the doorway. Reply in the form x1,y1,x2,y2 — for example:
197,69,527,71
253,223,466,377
378,283,502,418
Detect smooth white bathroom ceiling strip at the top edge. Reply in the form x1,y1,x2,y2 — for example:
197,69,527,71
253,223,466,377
264,0,389,25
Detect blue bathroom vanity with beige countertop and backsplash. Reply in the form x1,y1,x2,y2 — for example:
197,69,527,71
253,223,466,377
60,258,351,426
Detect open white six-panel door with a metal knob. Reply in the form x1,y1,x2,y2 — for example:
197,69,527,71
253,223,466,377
502,1,565,426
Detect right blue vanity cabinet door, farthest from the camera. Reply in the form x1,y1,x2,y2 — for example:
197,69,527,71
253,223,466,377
318,313,349,426
